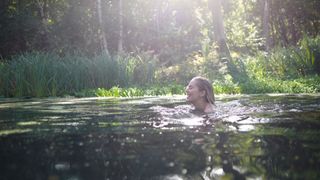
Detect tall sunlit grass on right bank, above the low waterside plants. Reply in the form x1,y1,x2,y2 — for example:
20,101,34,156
245,36,320,79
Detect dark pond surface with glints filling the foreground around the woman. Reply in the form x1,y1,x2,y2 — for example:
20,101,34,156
0,95,320,180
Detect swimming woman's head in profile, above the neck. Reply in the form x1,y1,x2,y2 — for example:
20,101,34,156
186,76,214,104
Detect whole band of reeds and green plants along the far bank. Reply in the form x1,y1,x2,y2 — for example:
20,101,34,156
0,37,320,97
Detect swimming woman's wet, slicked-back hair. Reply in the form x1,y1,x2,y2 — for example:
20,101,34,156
191,76,214,104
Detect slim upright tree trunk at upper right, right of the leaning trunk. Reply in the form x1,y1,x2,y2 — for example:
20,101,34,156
263,0,270,52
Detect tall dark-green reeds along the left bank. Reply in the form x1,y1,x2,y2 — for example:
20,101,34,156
0,52,158,97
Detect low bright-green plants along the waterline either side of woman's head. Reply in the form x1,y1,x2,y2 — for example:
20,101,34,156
73,76,320,97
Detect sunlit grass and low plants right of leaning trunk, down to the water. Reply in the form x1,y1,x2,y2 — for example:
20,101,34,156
229,37,320,93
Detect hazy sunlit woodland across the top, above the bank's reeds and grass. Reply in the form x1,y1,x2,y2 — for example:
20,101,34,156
0,0,320,59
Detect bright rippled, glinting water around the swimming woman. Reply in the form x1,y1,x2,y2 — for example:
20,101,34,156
150,97,281,128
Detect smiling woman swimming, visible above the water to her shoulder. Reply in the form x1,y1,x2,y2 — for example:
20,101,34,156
186,76,214,113
